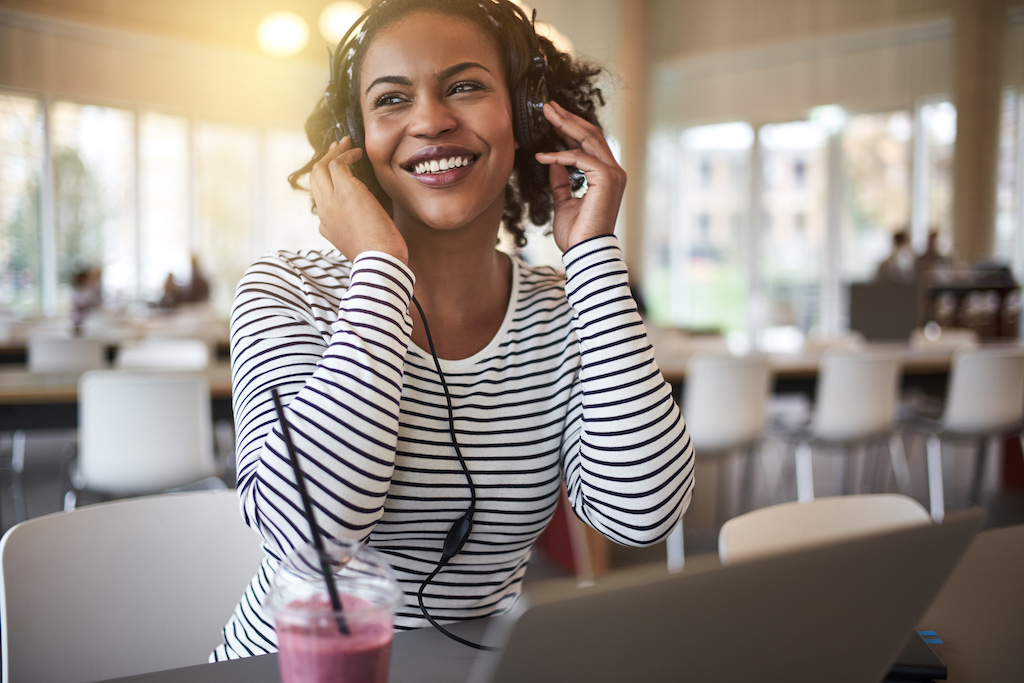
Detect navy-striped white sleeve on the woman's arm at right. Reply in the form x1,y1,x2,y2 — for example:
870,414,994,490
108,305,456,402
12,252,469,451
562,236,693,546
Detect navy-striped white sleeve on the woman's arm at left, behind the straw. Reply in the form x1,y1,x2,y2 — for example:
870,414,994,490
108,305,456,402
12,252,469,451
231,252,414,558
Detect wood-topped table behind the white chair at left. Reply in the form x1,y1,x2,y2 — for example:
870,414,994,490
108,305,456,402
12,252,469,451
0,361,231,432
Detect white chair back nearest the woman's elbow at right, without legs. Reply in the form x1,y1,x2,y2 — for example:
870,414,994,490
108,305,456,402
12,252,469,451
683,353,771,454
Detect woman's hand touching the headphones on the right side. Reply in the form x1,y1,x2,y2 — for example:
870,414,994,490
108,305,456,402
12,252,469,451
537,102,626,252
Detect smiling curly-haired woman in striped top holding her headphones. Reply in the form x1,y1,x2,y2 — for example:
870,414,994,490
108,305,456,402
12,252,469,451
214,0,693,658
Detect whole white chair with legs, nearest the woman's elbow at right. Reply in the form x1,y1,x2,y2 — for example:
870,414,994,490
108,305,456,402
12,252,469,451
666,352,771,569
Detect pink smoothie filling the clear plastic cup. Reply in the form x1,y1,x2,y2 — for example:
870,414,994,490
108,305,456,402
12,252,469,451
275,595,393,683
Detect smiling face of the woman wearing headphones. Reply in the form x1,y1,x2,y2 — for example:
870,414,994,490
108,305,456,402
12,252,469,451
359,11,515,235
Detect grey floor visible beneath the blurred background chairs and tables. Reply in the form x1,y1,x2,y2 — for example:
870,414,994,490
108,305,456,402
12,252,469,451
0,431,1024,578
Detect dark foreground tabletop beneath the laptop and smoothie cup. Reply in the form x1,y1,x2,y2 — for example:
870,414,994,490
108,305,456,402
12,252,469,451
96,524,1024,683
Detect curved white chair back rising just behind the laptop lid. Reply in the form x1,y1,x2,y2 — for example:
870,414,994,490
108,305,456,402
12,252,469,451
718,494,931,563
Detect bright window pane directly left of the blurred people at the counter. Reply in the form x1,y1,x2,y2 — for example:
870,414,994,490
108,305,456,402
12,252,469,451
842,111,912,281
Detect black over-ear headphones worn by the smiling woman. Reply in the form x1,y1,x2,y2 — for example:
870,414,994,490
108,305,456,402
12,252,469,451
321,0,553,155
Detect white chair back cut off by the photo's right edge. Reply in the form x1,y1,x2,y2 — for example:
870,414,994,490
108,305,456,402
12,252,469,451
942,347,1024,433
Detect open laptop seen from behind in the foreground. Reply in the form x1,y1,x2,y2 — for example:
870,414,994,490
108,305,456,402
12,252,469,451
470,509,983,683
